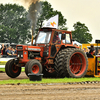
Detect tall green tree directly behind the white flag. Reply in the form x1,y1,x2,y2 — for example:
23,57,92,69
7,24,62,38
35,1,67,33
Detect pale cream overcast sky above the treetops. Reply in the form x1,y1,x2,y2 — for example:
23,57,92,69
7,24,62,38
0,0,100,43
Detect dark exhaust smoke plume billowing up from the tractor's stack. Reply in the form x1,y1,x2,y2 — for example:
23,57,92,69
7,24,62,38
14,0,43,32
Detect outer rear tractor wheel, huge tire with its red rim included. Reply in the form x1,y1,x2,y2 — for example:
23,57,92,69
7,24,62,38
64,48,88,78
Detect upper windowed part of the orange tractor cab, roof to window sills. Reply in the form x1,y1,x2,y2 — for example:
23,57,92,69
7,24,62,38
35,28,72,45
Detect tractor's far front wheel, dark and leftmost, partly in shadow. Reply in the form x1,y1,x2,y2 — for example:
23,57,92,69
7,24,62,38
5,59,21,78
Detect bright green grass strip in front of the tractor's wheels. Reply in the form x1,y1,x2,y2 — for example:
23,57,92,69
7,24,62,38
0,77,100,84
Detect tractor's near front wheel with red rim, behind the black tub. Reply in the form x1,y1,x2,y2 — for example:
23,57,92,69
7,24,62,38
28,59,42,74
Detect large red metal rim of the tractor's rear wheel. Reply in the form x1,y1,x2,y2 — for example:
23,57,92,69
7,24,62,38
70,52,86,76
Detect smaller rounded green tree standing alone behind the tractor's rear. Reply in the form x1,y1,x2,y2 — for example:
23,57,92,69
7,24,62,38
72,22,92,43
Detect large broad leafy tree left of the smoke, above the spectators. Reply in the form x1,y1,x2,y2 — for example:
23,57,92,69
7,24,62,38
0,4,31,44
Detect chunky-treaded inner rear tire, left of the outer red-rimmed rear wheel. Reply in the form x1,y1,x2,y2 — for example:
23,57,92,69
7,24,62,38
54,49,68,78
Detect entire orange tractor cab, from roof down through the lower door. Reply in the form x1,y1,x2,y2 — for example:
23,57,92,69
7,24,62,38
35,28,73,58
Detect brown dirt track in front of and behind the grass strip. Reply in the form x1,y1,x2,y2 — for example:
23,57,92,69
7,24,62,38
0,73,100,100
